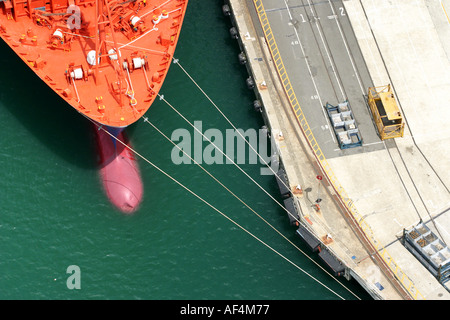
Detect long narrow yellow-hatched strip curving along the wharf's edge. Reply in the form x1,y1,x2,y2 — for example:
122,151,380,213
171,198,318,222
253,0,425,300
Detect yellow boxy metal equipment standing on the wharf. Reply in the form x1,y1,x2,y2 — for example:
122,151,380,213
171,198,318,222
367,84,405,140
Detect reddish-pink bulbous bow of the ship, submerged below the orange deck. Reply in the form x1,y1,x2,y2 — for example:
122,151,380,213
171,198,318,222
94,126,144,214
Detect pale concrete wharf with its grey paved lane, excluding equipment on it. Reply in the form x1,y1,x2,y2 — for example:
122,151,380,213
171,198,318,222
225,0,450,300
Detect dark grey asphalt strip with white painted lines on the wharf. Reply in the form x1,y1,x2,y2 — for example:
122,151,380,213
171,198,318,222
248,0,385,158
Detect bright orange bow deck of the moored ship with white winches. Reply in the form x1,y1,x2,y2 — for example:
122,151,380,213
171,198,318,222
0,0,188,127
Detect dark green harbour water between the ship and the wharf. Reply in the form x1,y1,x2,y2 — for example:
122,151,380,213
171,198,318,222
0,0,369,300
